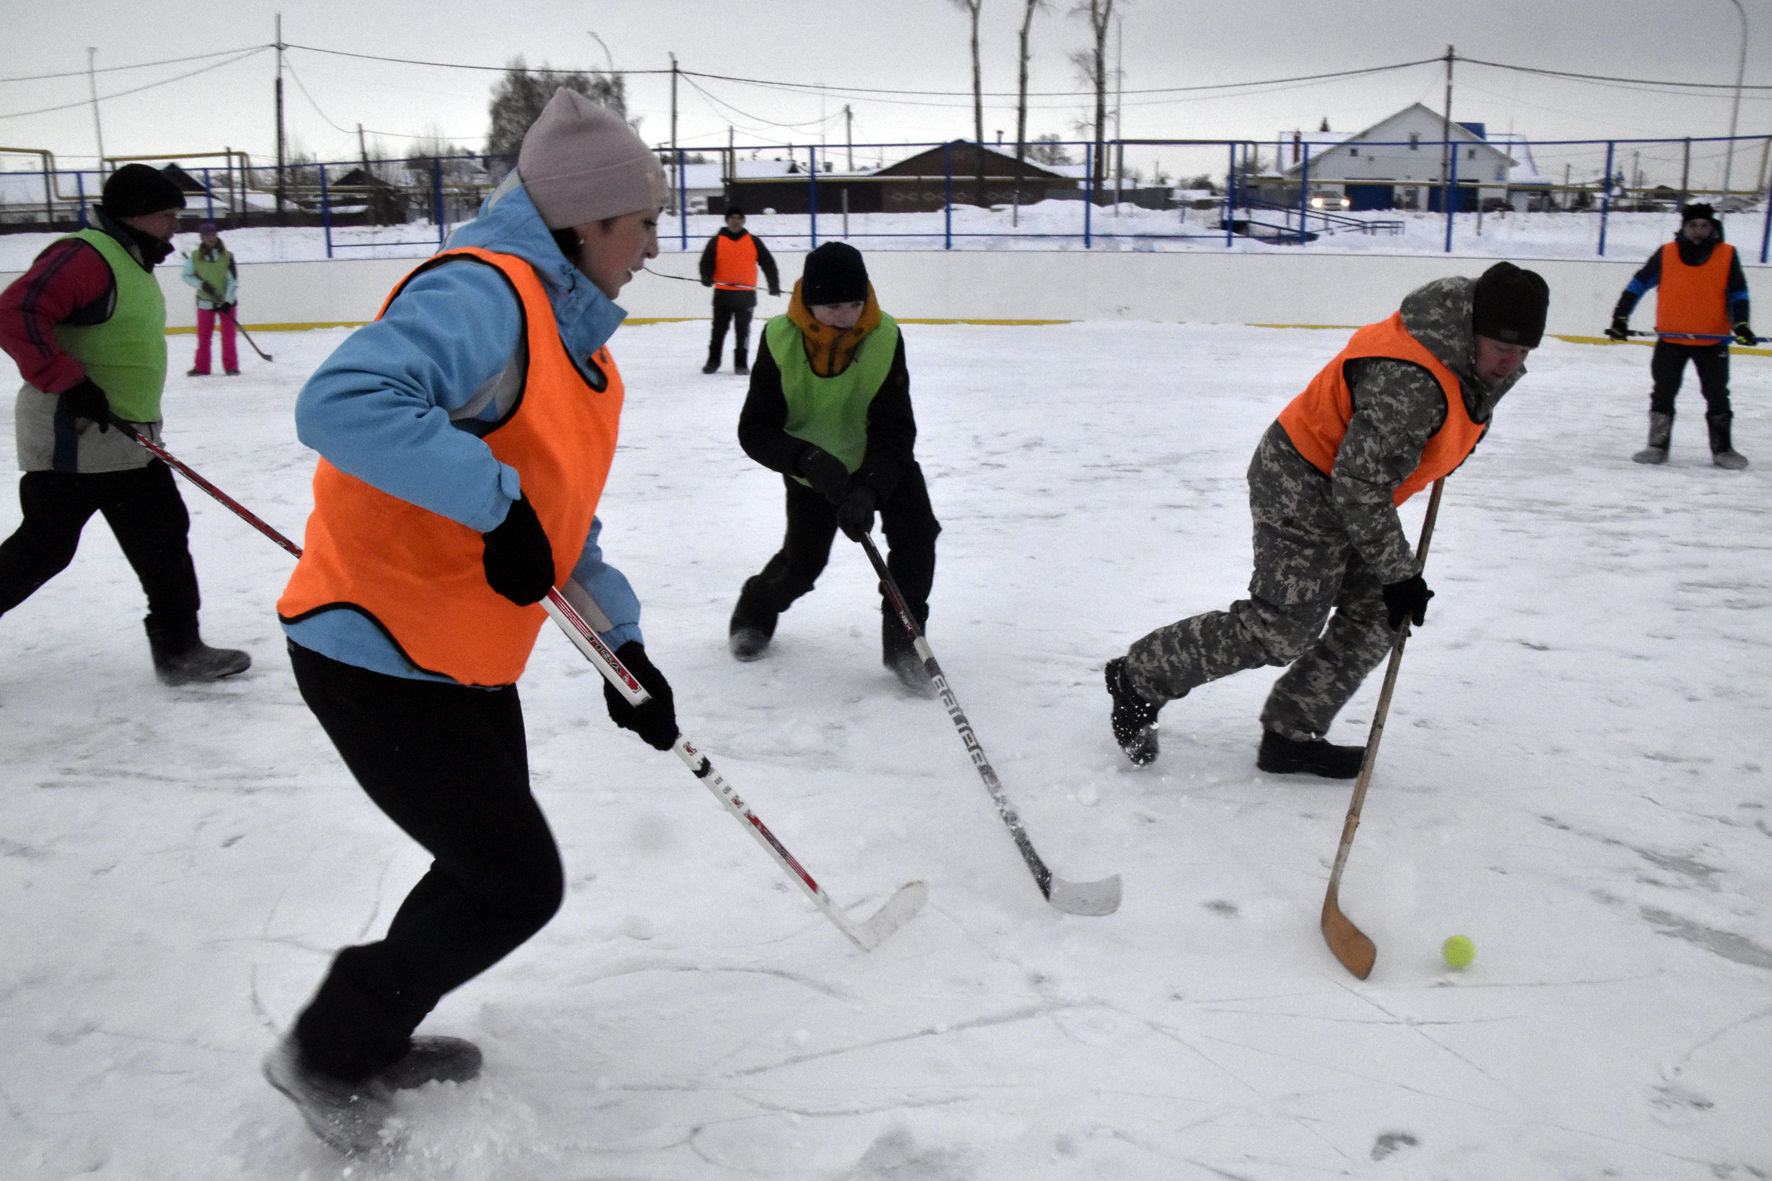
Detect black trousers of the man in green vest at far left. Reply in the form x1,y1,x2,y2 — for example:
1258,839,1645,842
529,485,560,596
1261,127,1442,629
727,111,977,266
0,459,200,647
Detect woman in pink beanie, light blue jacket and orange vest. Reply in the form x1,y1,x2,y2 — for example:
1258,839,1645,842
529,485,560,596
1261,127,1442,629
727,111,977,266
264,89,677,1154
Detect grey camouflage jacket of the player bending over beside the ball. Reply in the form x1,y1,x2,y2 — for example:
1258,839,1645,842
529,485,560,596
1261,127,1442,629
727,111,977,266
1249,278,1526,582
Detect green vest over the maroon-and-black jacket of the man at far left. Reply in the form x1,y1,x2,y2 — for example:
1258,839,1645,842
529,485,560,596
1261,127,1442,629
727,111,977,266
55,229,167,422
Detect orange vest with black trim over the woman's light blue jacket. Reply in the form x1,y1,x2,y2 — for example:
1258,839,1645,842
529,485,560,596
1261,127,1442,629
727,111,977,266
276,248,622,684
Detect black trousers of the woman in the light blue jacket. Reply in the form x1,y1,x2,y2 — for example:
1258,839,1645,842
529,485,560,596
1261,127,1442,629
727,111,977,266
289,644,565,1082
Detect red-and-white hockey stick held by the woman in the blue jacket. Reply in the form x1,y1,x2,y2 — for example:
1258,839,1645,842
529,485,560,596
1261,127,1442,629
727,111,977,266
542,583,929,950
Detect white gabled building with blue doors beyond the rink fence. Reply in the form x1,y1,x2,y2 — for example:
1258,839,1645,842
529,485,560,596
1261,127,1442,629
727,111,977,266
1278,103,1517,209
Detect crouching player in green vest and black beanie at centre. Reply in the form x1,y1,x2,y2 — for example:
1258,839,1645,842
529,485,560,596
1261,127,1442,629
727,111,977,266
727,241,941,695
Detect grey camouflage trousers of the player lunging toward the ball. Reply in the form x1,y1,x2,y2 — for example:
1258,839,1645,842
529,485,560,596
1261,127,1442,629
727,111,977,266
1127,456,1395,741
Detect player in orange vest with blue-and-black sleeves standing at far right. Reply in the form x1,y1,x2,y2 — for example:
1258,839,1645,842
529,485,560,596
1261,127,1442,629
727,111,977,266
1605,204,1758,468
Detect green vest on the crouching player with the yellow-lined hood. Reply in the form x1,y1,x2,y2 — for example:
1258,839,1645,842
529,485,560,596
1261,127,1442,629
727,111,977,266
764,312,898,484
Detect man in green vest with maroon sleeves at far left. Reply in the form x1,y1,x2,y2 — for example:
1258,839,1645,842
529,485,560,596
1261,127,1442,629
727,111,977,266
0,163,252,684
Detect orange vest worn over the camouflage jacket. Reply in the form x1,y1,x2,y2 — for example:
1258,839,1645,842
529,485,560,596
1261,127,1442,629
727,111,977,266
1279,312,1487,504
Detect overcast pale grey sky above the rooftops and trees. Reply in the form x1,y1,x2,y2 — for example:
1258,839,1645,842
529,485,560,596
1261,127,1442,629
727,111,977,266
0,0,1772,168
